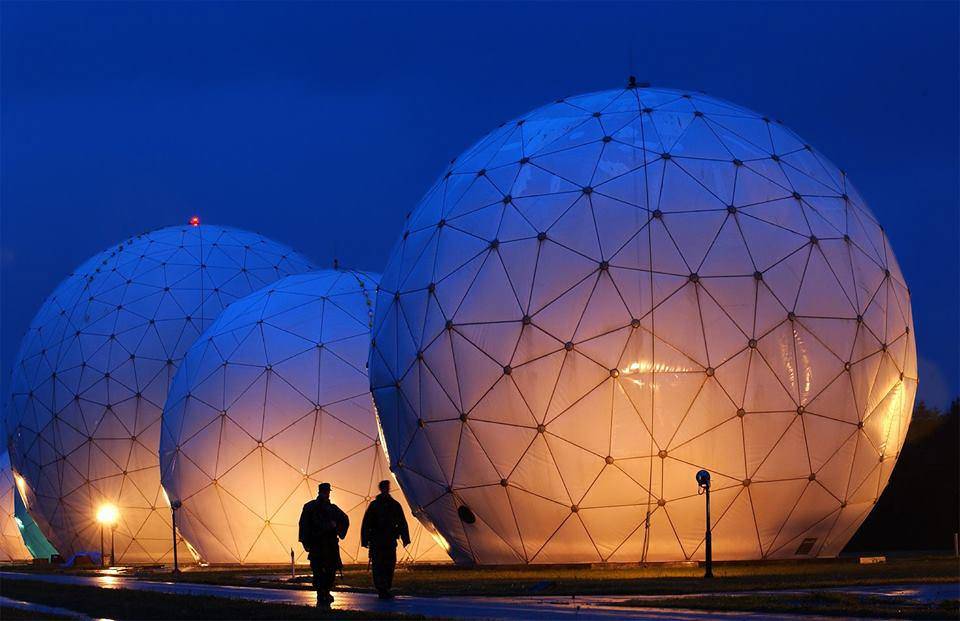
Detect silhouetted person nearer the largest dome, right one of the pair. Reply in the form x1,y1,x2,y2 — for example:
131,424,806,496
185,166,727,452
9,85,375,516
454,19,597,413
360,481,410,599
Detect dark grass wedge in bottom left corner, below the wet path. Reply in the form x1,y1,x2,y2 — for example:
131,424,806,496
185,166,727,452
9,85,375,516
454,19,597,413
0,580,424,621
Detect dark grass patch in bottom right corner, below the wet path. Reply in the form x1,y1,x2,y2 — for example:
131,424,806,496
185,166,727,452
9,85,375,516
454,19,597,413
621,593,960,619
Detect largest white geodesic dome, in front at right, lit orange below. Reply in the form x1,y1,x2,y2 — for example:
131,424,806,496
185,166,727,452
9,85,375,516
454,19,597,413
370,84,917,563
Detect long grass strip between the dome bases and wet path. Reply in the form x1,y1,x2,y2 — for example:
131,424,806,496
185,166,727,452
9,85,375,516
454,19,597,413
33,556,960,597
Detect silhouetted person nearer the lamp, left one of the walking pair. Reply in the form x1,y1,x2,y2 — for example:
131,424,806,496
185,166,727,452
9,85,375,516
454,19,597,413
300,483,350,606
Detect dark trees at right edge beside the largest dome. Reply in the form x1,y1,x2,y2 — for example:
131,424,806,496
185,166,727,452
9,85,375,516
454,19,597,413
844,400,960,553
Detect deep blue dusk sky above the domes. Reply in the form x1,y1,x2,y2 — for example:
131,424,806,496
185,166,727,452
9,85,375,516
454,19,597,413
0,2,960,404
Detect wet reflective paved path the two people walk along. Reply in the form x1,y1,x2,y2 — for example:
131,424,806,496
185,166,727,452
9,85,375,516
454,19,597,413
0,572,960,621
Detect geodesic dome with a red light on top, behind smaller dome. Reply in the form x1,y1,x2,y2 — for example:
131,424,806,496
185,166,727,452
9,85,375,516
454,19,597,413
7,225,310,563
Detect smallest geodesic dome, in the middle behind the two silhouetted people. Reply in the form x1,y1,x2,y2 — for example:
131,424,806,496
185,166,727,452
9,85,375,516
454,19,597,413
160,270,450,563
